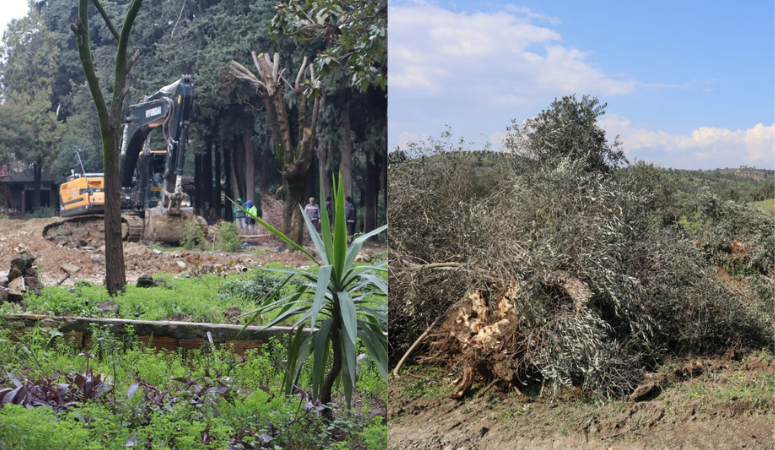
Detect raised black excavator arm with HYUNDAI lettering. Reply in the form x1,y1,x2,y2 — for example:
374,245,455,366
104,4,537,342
120,75,194,215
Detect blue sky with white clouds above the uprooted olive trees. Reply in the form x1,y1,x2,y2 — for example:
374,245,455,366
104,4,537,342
388,0,775,169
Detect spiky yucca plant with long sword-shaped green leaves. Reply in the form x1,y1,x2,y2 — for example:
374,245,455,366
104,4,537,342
232,174,388,413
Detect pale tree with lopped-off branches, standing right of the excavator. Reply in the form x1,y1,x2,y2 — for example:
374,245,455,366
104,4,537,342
229,52,322,245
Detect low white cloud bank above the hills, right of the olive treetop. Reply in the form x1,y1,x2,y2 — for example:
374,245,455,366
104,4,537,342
600,114,775,168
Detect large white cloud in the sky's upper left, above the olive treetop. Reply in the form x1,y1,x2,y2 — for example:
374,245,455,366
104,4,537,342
389,3,638,105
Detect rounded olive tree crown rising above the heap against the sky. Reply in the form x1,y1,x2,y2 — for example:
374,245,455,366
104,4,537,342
504,95,627,172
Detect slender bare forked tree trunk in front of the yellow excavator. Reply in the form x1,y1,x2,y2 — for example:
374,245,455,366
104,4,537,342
71,0,143,295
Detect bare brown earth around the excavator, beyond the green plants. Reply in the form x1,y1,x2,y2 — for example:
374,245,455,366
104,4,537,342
0,218,384,286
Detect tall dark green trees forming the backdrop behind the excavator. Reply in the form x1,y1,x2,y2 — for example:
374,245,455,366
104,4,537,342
0,0,387,232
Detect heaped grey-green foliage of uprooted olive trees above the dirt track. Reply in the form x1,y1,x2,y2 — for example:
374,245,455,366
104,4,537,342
388,127,773,396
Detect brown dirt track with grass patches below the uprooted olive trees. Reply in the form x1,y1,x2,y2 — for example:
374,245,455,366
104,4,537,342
388,354,775,450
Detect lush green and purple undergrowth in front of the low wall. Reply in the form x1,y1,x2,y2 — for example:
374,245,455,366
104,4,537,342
0,328,387,450
